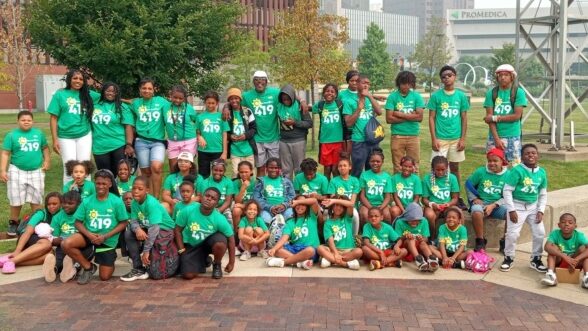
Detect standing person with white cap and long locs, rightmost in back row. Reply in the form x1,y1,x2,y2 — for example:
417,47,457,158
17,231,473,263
484,64,527,165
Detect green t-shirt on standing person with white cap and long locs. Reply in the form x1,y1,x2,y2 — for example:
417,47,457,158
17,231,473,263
484,87,527,138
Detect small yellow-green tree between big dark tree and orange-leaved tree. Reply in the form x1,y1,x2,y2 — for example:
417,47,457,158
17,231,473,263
222,33,270,90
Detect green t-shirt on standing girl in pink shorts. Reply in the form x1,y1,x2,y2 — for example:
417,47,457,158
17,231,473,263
163,102,198,141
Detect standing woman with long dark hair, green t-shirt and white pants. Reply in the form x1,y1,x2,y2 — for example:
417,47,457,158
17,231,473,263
47,69,98,184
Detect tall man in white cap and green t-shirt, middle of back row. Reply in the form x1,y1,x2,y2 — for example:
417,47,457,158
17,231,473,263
241,71,280,177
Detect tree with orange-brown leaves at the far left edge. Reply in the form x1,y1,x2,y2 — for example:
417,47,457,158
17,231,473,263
0,0,34,109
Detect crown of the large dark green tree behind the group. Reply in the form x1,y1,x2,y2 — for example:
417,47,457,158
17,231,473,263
27,0,242,97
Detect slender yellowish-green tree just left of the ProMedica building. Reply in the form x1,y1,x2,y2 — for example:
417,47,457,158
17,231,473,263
411,17,451,94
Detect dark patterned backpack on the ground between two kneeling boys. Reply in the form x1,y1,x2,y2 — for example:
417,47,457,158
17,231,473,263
149,230,180,280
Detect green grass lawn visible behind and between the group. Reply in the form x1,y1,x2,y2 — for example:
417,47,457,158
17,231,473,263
0,102,588,237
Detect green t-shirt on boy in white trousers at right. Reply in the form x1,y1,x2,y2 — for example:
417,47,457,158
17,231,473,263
506,163,547,203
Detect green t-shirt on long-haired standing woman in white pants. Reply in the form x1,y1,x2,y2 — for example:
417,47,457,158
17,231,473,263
47,89,94,139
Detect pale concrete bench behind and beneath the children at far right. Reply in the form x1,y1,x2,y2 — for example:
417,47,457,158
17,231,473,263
465,185,588,248
